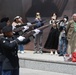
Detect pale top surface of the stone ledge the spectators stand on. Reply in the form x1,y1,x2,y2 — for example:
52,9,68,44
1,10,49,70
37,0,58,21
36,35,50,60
18,51,64,62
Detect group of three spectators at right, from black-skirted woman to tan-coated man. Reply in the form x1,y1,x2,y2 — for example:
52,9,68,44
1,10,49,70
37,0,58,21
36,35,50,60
44,13,76,56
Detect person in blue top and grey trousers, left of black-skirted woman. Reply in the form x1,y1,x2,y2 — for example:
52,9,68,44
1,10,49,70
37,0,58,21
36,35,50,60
34,12,43,54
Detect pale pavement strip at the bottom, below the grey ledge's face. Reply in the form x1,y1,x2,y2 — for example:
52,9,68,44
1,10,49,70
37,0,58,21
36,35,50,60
20,68,71,75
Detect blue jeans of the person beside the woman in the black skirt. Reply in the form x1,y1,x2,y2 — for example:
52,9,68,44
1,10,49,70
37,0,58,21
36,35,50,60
59,39,67,54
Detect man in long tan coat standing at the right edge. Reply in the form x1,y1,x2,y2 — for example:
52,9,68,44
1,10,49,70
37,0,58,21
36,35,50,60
67,13,76,54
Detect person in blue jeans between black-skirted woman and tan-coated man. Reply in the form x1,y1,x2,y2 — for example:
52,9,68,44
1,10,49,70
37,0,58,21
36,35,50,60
58,15,68,56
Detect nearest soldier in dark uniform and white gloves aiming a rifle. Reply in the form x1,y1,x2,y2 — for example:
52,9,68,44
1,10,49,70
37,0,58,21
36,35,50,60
0,26,40,75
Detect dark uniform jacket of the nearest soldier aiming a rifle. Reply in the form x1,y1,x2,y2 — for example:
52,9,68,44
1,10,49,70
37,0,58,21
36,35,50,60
0,37,28,70
